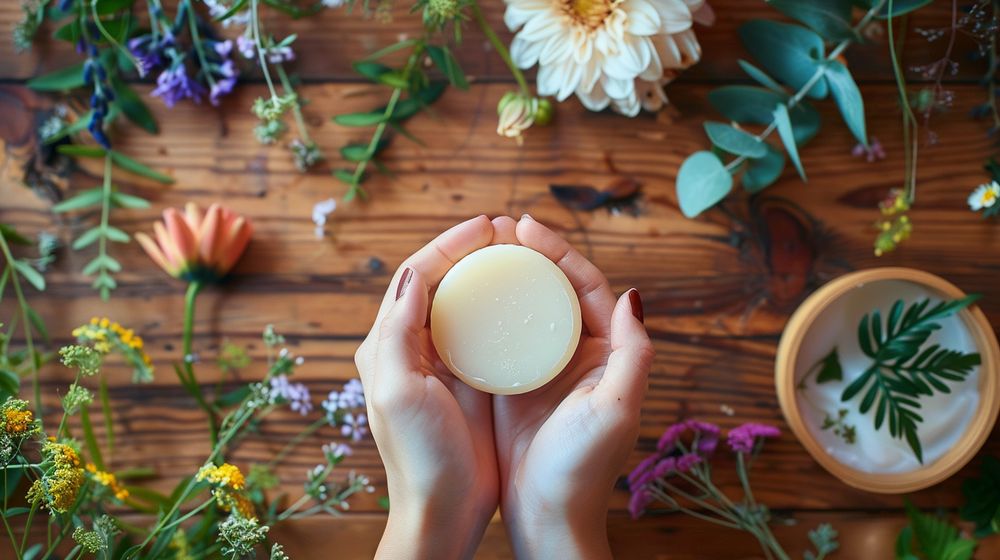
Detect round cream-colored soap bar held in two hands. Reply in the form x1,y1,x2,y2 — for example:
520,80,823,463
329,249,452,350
431,245,582,395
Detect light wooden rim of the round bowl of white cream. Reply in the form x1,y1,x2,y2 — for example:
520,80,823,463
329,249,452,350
774,268,1000,494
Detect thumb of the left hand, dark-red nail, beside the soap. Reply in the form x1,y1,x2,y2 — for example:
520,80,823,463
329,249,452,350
370,269,428,396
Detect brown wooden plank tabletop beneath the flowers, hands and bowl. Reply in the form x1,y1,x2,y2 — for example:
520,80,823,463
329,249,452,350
0,0,1000,558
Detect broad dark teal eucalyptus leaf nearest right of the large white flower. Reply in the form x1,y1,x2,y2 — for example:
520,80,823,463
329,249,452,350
740,20,828,99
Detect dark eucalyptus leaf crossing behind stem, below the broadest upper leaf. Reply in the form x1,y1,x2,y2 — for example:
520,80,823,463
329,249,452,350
708,86,820,146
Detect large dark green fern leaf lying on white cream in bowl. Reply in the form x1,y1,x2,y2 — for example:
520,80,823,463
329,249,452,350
841,295,980,463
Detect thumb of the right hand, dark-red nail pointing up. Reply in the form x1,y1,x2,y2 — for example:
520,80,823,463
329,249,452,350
594,288,653,411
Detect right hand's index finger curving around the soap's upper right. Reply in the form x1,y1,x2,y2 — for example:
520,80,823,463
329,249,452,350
517,214,615,337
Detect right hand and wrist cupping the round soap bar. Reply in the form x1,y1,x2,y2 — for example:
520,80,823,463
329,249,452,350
493,215,653,559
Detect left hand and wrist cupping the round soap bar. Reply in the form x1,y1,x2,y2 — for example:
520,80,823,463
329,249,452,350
355,216,504,559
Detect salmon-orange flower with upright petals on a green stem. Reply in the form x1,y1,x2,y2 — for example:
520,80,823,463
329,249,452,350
135,203,253,281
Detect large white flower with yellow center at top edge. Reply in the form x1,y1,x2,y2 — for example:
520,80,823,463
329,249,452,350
504,0,707,116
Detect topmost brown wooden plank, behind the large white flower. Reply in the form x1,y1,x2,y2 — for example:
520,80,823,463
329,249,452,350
0,0,986,82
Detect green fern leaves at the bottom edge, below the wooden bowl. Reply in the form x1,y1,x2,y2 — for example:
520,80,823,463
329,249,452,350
896,500,978,560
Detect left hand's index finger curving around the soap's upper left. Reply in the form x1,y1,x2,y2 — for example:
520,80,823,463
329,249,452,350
373,215,493,329
